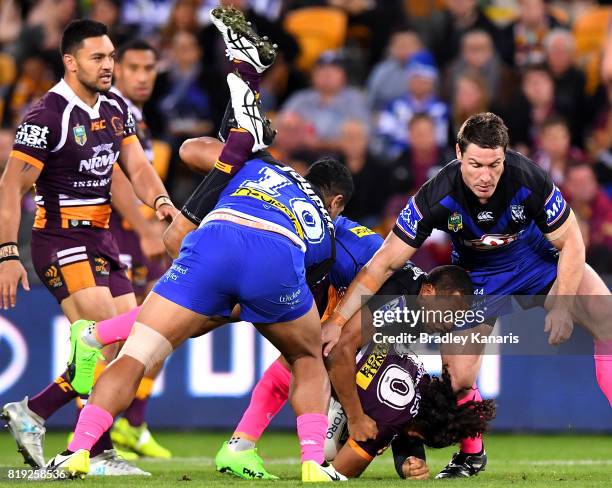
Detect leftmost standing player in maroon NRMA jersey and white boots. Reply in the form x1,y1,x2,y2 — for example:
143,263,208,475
0,20,177,474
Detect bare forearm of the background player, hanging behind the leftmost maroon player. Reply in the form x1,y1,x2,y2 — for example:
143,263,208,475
111,166,166,259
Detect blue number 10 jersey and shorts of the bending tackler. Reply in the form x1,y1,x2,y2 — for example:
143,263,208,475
153,159,334,323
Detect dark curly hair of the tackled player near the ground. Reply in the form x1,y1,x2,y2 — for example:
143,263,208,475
411,368,495,448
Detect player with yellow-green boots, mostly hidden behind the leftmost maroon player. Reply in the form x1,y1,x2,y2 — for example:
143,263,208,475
110,39,171,458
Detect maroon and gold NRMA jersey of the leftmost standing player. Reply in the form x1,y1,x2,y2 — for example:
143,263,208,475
10,80,138,229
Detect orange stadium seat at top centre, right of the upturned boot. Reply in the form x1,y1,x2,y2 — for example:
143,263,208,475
284,7,348,72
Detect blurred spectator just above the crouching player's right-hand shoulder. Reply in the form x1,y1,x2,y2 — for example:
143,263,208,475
533,117,585,186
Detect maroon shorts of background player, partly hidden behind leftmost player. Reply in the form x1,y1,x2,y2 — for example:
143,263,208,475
110,211,170,295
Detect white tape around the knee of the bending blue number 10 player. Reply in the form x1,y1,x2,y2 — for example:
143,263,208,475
118,322,172,373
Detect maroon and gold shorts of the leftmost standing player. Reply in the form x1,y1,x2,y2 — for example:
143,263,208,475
32,228,133,303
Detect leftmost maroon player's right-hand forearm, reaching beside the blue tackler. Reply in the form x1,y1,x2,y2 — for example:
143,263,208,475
119,140,178,222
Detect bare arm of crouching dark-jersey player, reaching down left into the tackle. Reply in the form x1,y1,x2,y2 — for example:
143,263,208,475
323,231,417,356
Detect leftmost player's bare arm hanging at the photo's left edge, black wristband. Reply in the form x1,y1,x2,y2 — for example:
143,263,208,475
0,157,41,310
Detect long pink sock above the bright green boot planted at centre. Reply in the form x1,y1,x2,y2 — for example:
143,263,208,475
235,360,291,441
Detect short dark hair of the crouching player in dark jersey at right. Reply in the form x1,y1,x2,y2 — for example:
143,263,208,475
457,112,509,153
